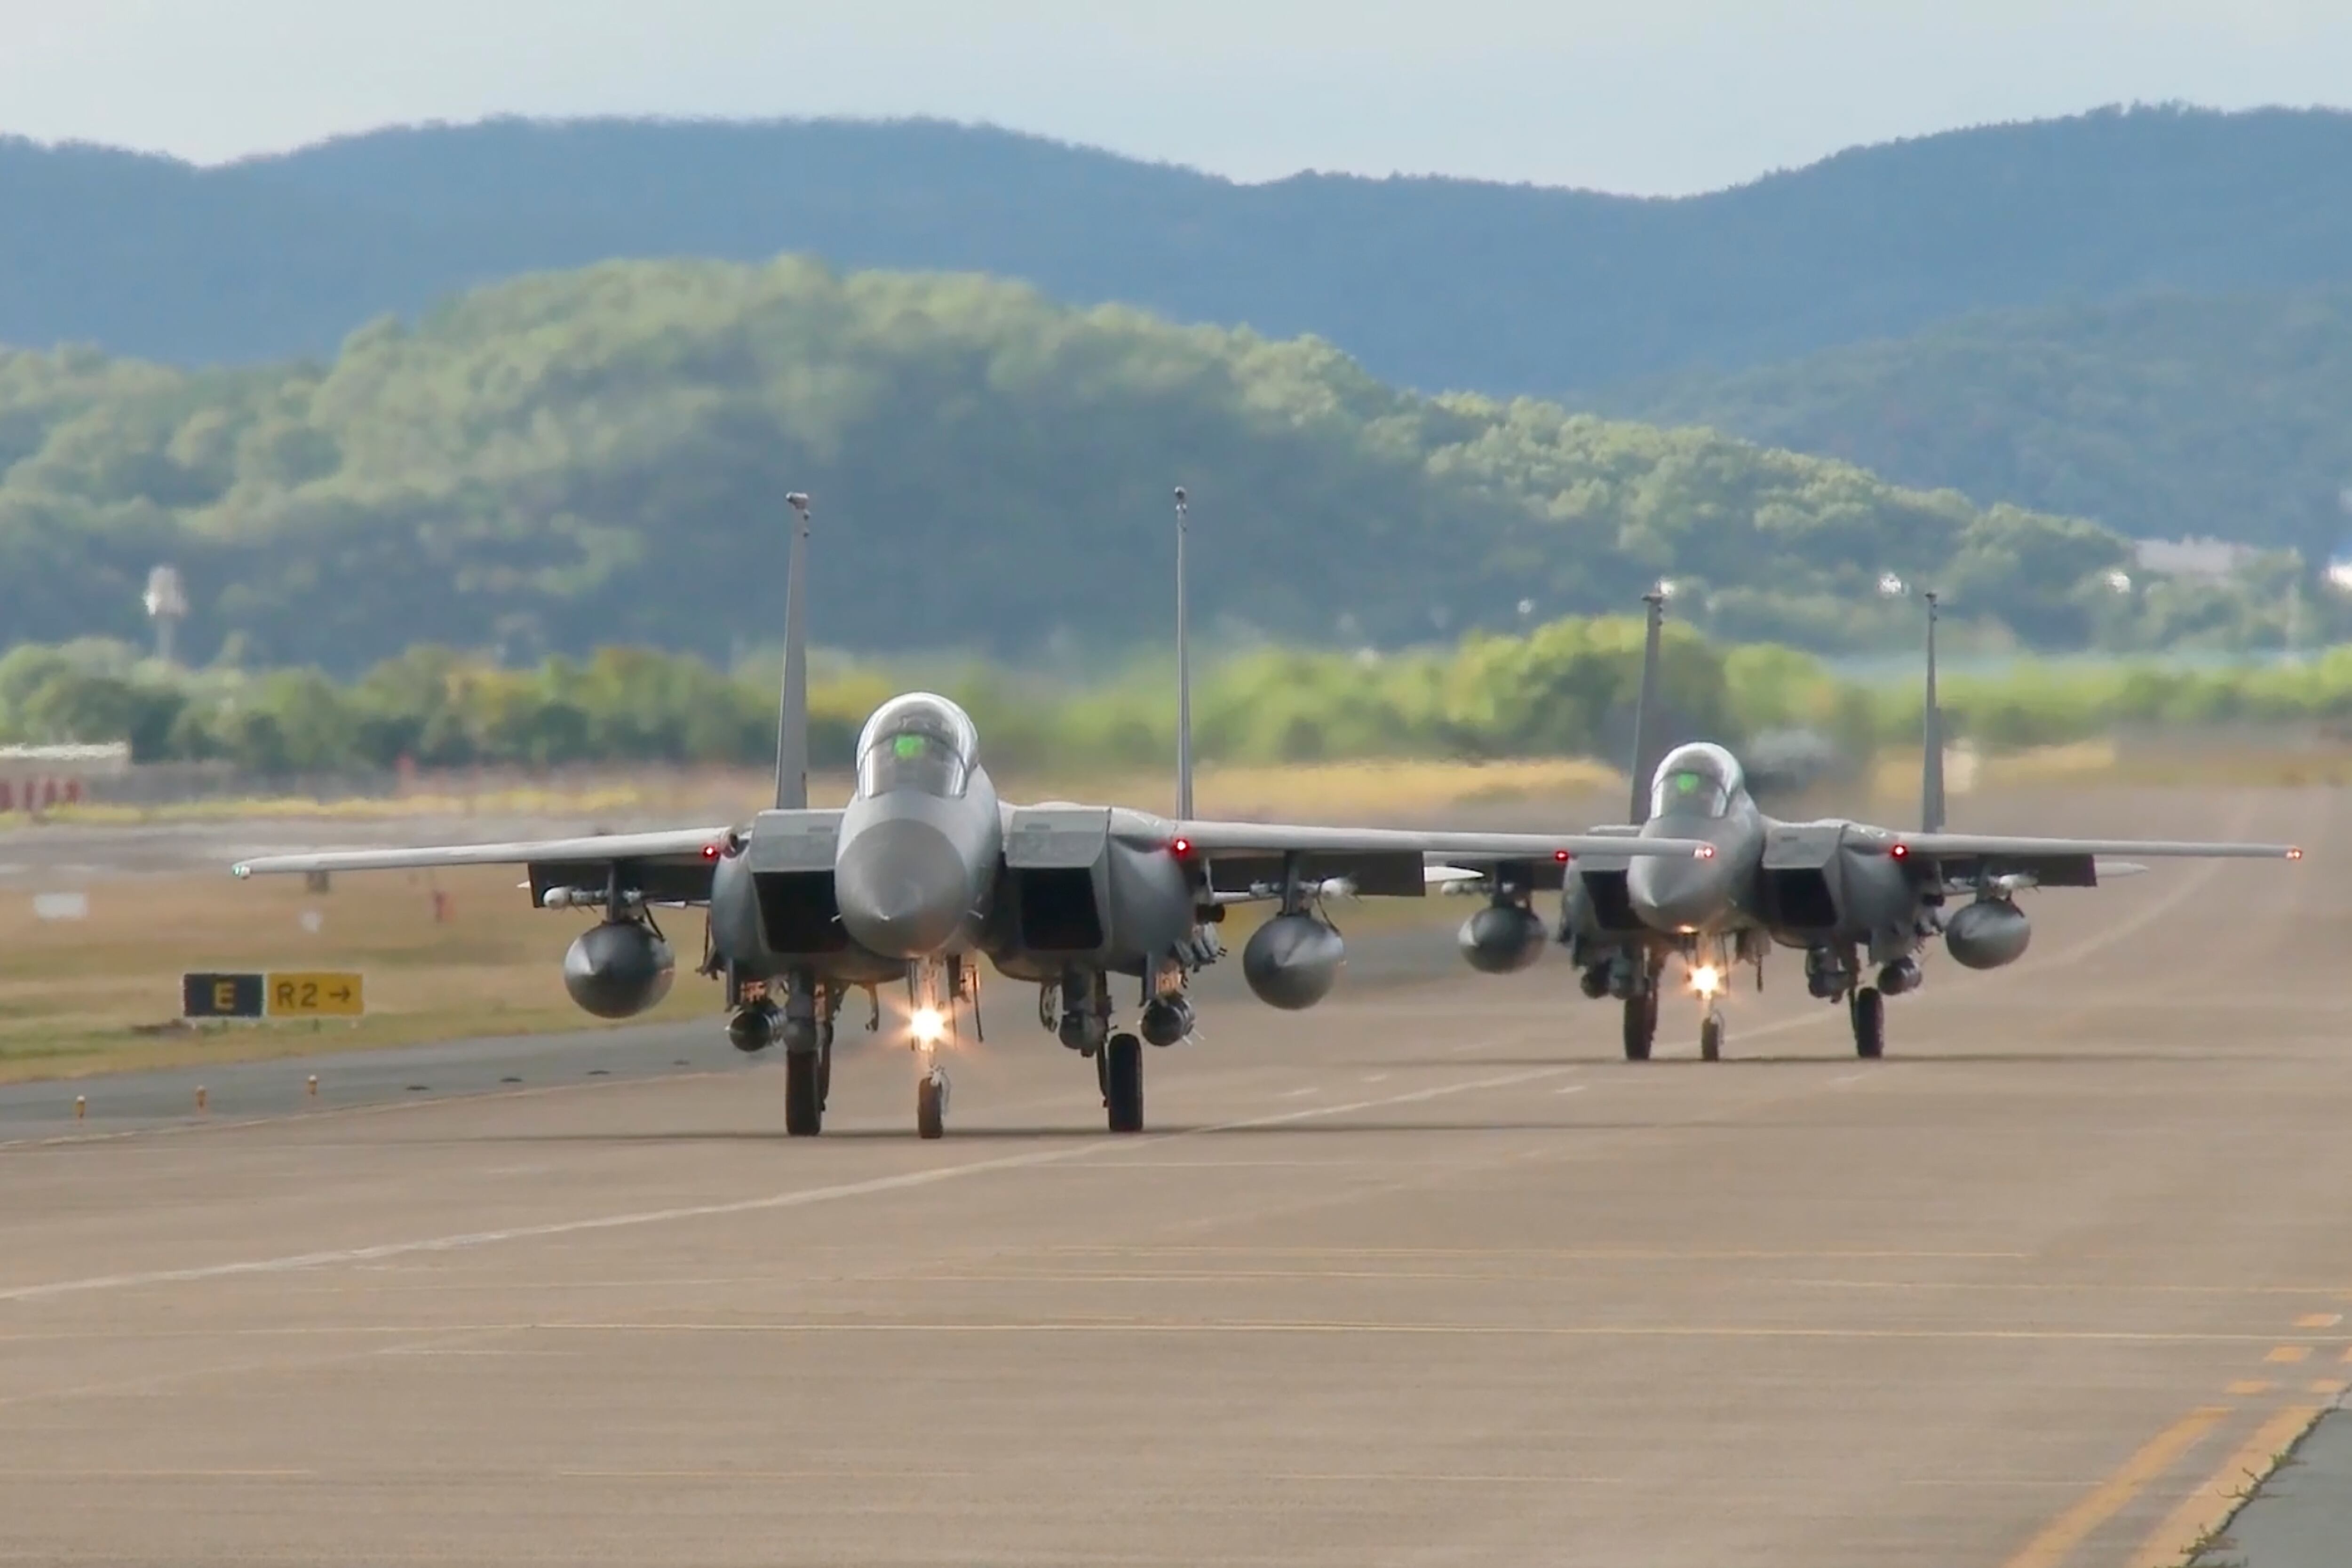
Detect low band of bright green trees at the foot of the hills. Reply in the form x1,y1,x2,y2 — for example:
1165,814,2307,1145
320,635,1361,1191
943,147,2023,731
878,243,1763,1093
0,618,2352,776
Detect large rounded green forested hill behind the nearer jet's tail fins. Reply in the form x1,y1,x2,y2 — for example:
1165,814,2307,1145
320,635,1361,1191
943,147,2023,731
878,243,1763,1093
0,261,2201,670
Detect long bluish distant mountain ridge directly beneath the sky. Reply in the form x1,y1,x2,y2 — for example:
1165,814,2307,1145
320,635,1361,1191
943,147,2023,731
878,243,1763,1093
0,111,2352,395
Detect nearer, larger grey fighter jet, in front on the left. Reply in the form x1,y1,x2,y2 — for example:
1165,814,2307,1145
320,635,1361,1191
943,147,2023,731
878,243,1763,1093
233,489,1712,1138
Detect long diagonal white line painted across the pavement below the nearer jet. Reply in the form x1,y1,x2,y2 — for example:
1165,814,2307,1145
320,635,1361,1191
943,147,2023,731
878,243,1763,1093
0,1067,1566,1302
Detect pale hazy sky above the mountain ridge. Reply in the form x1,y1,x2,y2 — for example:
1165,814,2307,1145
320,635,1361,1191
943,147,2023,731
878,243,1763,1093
0,0,2352,193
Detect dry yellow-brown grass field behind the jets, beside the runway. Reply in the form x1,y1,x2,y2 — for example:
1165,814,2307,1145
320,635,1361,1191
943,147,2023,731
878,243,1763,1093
0,745,2333,1082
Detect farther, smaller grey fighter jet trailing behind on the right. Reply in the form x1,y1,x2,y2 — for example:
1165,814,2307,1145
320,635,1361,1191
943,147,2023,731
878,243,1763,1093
1461,592,2303,1060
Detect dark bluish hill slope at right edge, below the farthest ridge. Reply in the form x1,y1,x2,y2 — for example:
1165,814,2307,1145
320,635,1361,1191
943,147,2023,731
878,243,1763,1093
1597,285,2352,562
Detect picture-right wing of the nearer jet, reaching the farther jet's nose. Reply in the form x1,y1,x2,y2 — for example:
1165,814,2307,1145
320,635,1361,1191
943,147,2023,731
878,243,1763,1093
1176,823,1715,898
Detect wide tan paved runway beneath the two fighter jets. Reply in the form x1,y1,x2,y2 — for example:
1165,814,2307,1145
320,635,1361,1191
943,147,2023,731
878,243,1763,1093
0,792,2352,1568
